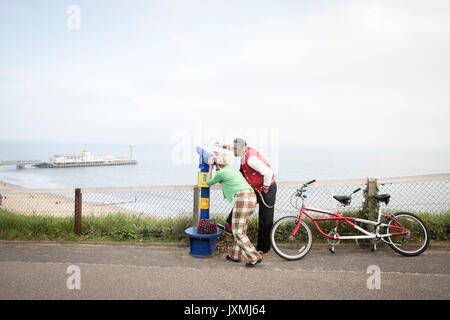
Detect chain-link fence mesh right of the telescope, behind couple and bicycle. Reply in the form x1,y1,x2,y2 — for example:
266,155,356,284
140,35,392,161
211,174,450,219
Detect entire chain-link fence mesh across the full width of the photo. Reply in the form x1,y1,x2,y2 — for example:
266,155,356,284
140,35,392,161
0,174,450,239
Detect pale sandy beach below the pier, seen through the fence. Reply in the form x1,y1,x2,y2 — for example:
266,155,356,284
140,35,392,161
0,181,136,217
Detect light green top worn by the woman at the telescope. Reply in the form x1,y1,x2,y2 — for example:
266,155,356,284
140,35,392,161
206,165,253,202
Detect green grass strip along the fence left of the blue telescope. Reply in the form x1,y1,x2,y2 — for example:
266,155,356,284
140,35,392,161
0,209,192,242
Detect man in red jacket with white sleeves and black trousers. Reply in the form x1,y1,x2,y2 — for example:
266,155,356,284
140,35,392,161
216,138,277,254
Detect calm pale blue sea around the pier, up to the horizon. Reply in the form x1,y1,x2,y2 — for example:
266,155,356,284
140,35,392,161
0,141,450,188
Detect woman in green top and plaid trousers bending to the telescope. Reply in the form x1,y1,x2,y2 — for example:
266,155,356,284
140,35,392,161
206,151,262,267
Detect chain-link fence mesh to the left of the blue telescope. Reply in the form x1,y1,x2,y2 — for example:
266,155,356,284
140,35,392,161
0,186,193,218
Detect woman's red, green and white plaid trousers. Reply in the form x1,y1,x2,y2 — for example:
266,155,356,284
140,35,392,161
230,190,261,263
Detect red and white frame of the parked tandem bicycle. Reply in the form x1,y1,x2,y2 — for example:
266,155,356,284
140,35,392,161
291,203,409,240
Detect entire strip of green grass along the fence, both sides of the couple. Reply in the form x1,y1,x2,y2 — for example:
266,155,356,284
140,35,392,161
0,209,450,246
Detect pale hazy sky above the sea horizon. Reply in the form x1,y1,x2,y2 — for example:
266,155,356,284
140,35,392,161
0,0,450,150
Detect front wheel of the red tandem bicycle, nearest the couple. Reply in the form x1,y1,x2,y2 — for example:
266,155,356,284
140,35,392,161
270,216,312,260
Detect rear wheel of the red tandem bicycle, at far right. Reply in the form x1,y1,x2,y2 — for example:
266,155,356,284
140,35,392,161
386,212,430,256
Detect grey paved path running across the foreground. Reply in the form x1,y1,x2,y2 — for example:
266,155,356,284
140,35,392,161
0,242,450,300
